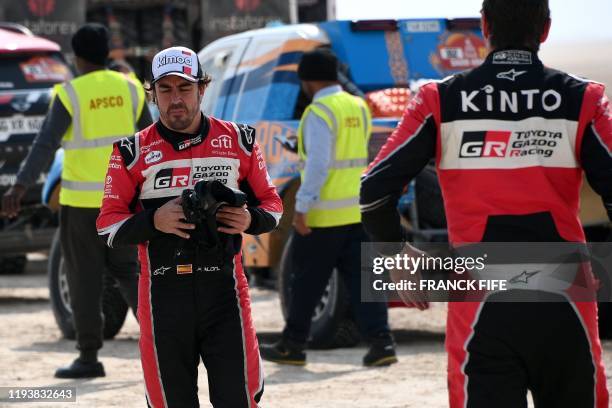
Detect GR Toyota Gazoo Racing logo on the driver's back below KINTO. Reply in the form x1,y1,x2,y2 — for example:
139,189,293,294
459,130,563,158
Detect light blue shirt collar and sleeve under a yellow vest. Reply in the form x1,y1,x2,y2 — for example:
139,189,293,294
295,85,342,213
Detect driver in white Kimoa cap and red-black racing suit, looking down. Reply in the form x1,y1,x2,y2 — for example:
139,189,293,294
97,47,282,408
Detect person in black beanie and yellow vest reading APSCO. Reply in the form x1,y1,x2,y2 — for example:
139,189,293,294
2,24,152,378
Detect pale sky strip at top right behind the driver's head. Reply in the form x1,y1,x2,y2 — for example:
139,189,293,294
336,0,612,44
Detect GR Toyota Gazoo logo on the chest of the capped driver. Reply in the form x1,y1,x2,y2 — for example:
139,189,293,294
153,165,233,190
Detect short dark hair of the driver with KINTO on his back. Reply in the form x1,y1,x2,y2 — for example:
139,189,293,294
482,0,550,51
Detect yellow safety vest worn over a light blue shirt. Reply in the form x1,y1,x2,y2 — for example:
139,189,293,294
298,92,372,228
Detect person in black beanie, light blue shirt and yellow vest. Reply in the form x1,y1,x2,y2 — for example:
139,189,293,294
261,49,397,366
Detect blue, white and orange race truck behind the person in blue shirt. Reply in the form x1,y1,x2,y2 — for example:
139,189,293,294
198,19,609,348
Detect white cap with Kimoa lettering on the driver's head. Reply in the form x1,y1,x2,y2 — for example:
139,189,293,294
151,47,202,84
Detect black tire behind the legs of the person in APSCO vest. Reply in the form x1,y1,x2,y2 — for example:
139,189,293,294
47,229,128,340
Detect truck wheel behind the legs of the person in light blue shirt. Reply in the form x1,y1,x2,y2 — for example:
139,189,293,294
278,231,360,349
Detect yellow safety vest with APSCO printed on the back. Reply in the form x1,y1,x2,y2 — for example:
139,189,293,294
55,70,145,208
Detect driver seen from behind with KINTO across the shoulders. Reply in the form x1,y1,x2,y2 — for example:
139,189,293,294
360,0,612,408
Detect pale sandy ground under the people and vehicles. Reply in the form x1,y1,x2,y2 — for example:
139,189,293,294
0,258,612,408
